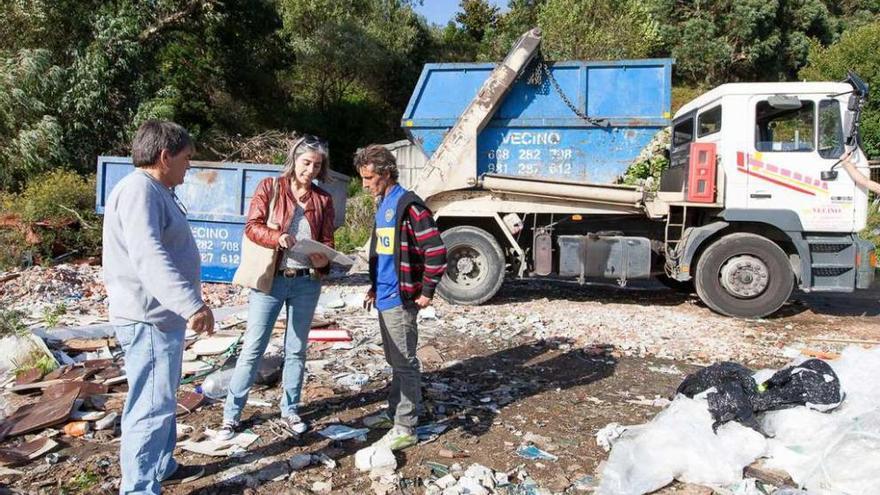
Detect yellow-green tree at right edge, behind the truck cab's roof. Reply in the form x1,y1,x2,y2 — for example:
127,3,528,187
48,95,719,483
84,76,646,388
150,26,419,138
798,21,880,158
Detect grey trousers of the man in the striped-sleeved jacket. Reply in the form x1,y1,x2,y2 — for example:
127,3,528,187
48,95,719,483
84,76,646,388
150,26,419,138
379,305,422,428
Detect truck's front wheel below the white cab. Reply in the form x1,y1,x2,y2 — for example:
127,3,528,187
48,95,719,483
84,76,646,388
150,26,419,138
695,232,794,318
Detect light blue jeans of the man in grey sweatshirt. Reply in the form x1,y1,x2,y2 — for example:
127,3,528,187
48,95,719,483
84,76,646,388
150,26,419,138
115,323,186,495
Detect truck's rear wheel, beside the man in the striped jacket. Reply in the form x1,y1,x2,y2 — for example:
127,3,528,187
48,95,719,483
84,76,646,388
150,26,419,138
437,225,504,305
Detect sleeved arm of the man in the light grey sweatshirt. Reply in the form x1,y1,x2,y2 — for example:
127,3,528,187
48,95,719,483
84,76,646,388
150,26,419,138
116,188,205,320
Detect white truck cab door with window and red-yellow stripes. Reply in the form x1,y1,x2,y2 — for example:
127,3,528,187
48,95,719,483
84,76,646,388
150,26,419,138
737,95,855,232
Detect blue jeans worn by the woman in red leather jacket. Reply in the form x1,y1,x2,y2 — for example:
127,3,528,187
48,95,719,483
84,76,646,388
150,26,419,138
223,276,321,422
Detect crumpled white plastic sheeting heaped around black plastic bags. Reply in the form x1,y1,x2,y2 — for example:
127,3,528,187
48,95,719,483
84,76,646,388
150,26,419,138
597,346,880,495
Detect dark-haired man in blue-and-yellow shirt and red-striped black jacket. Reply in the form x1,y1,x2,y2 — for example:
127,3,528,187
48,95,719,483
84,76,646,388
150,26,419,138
354,145,446,450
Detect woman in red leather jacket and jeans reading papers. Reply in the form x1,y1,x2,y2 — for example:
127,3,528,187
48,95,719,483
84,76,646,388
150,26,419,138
219,135,334,438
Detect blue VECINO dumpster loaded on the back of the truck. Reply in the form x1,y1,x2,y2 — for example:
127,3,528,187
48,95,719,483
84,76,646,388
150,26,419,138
401,59,673,183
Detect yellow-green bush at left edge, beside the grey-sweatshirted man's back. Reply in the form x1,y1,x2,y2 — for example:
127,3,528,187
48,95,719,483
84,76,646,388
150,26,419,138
0,169,101,266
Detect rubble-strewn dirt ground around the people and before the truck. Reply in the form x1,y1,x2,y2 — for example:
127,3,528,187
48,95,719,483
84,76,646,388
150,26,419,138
0,265,876,494
